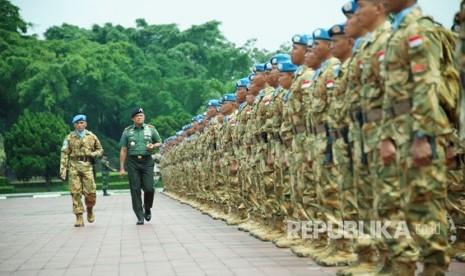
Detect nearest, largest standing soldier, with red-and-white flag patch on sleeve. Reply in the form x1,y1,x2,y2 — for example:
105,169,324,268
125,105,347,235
380,0,452,275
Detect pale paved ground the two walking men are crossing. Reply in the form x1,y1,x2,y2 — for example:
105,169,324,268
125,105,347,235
0,194,465,276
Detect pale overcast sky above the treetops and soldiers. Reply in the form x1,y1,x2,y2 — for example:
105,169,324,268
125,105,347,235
10,0,460,51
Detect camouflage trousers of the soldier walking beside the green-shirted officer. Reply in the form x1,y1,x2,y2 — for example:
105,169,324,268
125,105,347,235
69,160,96,214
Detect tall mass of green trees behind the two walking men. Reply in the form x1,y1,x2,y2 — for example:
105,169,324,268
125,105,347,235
0,0,271,179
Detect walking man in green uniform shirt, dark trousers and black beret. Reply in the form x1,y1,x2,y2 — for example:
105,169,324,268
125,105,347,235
119,107,162,225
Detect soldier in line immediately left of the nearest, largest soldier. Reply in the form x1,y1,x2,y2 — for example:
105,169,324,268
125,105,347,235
350,0,394,273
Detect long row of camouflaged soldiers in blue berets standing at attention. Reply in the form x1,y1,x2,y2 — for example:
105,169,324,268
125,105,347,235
161,0,465,275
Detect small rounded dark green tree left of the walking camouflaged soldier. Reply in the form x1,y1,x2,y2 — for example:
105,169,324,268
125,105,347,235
5,110,69,191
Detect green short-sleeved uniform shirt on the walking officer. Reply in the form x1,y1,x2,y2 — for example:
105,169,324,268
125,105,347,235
119,124,161,155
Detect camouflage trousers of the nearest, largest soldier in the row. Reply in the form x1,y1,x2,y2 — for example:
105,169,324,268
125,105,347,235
393,138,450,267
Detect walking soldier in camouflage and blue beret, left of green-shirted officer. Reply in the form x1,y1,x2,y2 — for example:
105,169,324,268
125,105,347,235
60,114,103,227
